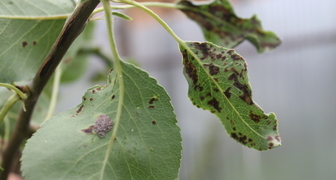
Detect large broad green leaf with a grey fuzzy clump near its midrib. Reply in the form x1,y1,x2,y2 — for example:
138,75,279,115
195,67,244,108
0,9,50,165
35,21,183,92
22,63,182,180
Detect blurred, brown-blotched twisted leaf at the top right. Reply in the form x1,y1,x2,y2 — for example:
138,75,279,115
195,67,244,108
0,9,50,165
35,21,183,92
177,0,281,53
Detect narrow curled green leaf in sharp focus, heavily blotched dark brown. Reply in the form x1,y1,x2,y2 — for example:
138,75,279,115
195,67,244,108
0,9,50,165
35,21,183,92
180,42,281,151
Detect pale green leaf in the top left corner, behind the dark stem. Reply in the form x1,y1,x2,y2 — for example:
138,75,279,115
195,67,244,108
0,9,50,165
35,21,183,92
0,0,75,83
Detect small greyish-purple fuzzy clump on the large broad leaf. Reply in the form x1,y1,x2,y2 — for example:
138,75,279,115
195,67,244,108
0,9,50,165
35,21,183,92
93,114,113,138
